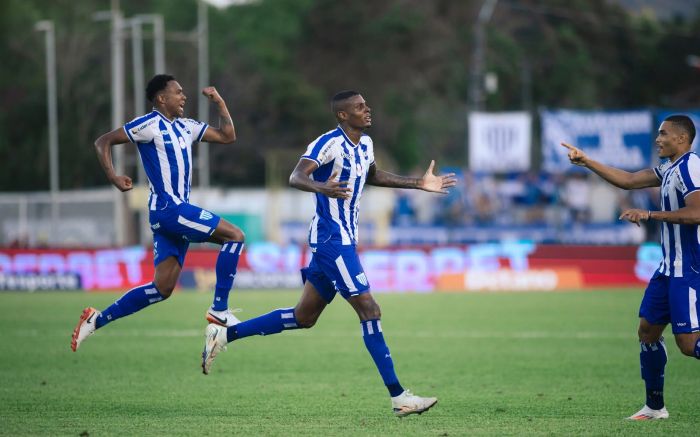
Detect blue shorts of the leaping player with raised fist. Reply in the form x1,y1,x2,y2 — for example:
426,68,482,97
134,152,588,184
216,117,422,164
149,203,221,266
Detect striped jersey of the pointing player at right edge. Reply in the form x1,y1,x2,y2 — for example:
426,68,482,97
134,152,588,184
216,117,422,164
654,152,700,277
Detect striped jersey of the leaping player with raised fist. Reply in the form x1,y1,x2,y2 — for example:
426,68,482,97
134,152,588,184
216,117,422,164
124,109,209,210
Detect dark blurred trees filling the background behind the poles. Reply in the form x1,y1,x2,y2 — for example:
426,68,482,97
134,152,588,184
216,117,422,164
0,0,700,191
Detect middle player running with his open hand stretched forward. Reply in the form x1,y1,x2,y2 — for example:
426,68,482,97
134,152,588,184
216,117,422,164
202,91,456,416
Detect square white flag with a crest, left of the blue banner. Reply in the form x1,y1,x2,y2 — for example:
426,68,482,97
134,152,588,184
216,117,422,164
469,112,532,172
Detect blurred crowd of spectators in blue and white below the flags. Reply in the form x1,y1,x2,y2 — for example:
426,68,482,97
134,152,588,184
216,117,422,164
392,171,659,241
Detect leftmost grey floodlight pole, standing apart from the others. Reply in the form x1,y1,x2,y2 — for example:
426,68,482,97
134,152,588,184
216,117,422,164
34,20,60,242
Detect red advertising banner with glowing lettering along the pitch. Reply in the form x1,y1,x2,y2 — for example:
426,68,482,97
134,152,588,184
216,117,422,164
0,242,661,292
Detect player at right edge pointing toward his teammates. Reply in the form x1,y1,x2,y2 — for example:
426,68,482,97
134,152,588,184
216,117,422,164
562,115,700,420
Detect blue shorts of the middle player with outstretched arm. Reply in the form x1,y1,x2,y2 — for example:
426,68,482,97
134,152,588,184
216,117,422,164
301,243,369,303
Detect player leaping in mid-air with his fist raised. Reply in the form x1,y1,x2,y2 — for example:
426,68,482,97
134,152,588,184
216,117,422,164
71,74,245,351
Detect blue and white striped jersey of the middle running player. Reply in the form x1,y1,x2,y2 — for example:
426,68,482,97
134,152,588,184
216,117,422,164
302,126,374,245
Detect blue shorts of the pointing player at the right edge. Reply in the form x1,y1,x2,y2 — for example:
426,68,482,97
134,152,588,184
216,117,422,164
639,270,700,334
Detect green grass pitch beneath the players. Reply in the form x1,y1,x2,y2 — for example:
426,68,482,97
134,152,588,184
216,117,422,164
0,291,700,436
